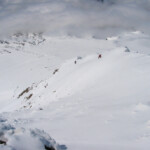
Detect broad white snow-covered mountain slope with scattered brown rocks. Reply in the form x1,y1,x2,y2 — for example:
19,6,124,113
0,32,150,150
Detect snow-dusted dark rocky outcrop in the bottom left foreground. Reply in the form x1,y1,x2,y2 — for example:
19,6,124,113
0,122,66,150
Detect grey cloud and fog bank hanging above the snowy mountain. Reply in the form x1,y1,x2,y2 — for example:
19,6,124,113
0,0,150,38
